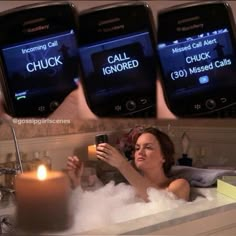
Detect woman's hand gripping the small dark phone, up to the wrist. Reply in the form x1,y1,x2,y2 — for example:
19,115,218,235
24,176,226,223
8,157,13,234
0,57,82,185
96,143,127,170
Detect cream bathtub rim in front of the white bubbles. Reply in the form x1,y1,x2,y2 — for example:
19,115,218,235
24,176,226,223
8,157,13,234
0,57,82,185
79,187,236,235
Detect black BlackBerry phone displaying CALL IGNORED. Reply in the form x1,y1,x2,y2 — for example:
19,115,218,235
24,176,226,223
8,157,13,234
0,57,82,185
79,2,157,117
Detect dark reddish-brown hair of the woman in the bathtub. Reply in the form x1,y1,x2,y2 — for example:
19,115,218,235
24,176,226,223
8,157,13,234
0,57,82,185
135,127,175,175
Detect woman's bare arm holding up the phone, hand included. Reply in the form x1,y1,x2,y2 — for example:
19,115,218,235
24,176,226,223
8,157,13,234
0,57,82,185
96,143,157,201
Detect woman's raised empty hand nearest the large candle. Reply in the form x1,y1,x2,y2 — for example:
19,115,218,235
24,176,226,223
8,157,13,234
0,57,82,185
67,156,84,188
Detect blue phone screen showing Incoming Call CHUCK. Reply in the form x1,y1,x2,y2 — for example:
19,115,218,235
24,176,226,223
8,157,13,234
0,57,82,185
1,30,78,101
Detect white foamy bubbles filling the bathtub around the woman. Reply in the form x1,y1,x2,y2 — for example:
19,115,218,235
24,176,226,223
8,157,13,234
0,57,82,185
70,181,186,233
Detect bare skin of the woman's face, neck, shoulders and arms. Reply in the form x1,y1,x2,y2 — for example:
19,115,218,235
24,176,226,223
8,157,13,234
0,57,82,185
68,133,190,201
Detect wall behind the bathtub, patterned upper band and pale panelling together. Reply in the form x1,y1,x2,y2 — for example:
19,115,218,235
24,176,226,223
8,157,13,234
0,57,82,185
0,119,236,169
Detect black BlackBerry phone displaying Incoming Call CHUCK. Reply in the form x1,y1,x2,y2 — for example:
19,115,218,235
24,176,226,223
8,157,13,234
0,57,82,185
0,2,79,117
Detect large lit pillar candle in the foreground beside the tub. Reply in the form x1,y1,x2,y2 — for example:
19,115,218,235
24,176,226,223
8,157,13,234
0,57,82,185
15,166,72,232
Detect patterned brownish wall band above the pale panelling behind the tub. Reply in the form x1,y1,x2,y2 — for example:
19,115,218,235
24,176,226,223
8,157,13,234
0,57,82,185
0,119,158,140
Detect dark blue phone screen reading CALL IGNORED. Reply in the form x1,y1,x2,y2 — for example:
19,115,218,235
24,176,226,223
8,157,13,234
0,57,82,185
79,32,156,104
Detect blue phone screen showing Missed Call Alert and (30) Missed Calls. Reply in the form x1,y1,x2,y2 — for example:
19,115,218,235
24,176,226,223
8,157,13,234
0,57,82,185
157,28,236,99
